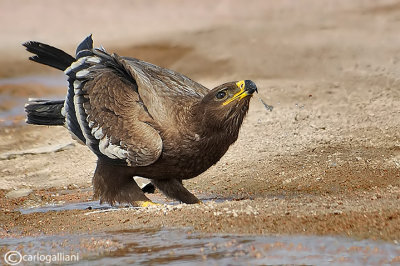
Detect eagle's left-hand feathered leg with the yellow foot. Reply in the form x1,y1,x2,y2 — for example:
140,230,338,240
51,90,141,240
93,160,155,207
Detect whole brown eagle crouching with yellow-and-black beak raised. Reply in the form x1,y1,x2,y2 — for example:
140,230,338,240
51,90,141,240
23,35,257,206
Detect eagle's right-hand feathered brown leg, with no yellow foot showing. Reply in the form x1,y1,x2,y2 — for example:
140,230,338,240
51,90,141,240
151,179,201,204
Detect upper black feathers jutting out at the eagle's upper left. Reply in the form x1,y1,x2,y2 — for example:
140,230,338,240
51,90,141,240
22,41,75,71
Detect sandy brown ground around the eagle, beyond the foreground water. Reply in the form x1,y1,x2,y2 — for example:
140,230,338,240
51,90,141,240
0,0,400,243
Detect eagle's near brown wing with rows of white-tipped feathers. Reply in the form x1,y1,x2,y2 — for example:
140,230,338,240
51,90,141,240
64,47,163,166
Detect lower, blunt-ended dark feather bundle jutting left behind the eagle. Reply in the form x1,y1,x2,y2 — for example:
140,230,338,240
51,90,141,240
25,99,65,126
